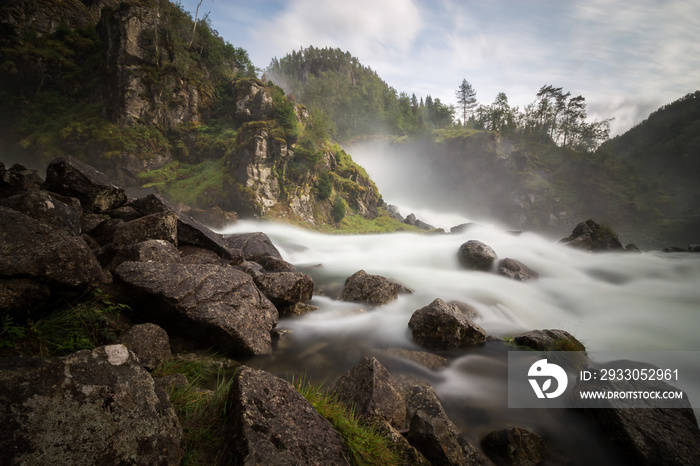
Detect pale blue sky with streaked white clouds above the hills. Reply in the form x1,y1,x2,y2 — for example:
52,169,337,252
180,0,700,134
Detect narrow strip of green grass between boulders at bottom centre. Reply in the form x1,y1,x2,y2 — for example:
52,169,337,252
293,377,403,465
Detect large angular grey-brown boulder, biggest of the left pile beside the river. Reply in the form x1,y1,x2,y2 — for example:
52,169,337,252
114,262,278,356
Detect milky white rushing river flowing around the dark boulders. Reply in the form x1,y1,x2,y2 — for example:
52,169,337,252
219,217,700,464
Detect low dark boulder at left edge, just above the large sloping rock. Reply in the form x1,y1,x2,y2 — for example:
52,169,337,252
0,190,82,236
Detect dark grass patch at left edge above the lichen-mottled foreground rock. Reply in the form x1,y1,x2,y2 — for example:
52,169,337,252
0,290,129,357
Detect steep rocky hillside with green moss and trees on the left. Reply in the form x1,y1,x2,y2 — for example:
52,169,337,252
0,0,388,228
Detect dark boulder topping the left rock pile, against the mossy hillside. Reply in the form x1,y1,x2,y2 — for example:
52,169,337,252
44,157,126,213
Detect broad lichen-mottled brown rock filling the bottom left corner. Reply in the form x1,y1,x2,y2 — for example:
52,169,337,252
0,345,184,466
